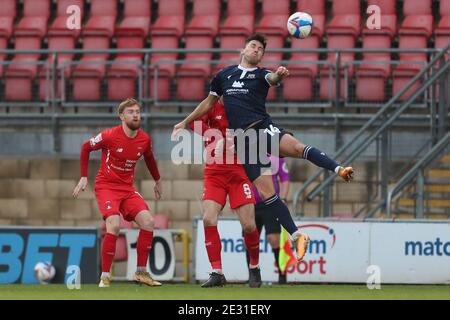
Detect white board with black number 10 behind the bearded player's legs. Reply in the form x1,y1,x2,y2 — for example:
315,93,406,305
122,229,176,281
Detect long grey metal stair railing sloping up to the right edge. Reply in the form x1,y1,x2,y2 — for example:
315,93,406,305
293,45,450,217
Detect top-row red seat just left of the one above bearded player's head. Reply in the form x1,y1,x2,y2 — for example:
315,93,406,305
83,0,117,38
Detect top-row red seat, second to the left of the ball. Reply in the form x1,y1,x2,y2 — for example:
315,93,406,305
220,0,255,36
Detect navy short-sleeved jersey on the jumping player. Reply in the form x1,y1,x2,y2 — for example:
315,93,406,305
210,65,271,129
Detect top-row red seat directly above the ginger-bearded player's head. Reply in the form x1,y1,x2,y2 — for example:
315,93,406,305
116,0,152,37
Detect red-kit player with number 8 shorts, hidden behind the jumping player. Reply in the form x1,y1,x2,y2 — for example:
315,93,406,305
189,100,262,287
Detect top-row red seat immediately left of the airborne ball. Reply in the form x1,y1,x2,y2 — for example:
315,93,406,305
256,0,290,37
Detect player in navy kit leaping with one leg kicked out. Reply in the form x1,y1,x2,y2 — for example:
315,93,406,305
172,33,353,261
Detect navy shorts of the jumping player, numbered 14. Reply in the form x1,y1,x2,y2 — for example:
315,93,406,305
235,118,292,182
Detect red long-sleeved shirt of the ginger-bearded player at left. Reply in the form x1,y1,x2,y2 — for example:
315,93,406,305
80,125,160,189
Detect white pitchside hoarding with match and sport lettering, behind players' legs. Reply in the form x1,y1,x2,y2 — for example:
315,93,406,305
195,220,450,283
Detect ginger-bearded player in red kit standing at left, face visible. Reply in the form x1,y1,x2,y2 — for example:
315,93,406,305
73,99,161,287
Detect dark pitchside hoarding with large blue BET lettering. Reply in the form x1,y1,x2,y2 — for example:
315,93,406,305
0,227,99,284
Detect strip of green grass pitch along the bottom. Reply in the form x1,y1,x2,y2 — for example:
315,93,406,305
0,283,450,300
